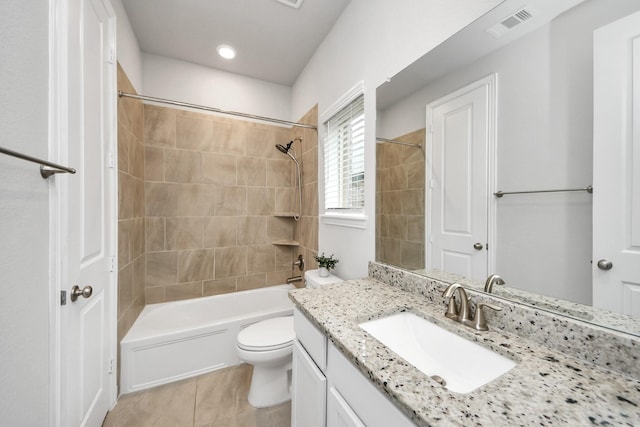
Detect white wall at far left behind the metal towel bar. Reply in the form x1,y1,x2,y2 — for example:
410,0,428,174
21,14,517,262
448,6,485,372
0,0,50,426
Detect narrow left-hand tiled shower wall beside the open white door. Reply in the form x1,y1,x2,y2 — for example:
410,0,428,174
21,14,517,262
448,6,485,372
118,64,145,354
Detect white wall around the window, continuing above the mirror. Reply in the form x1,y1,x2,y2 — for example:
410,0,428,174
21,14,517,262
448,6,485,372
292,0,500,278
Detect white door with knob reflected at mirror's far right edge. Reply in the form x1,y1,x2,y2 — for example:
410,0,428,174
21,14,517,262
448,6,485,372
593,13,640,317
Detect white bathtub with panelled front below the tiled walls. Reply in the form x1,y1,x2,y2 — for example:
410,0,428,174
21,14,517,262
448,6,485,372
120,285,295,394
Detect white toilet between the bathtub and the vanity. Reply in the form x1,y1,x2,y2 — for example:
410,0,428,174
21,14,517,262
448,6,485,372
236,270,342,408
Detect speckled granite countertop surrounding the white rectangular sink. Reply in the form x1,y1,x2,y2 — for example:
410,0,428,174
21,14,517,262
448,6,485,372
289,278,640,426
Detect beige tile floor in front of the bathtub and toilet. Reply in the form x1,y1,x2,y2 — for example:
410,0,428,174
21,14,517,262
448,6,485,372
103,364,291,427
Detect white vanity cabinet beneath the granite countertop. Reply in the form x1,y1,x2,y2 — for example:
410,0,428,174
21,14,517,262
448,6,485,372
291,309,414,427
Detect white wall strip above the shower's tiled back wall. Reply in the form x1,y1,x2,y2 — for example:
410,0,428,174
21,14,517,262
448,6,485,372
142,53,292,120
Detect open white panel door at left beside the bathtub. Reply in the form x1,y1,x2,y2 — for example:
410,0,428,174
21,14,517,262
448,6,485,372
60,0,117,426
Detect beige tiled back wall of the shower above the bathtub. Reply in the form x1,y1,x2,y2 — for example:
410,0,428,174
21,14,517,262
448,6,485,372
144,105,317,304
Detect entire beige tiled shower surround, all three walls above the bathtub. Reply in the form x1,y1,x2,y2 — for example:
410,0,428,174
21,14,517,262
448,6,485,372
118,64,318,310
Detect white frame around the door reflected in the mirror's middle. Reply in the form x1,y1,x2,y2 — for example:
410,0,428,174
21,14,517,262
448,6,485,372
425,73,498,274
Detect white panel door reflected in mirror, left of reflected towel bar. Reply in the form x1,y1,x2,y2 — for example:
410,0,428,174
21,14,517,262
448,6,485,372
425,75,497,280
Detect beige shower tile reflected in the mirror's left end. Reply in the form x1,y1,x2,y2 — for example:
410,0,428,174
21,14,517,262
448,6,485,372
376,129,425,269
